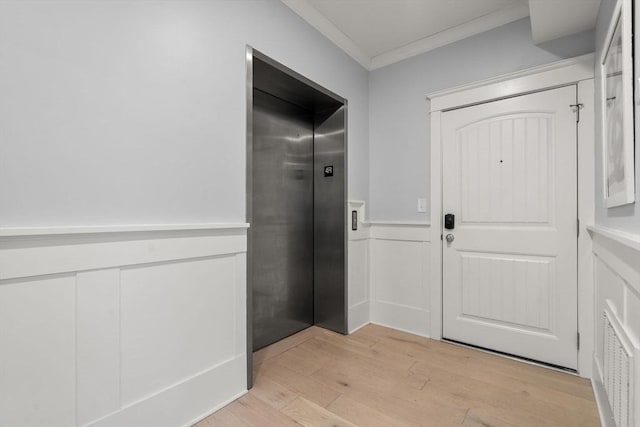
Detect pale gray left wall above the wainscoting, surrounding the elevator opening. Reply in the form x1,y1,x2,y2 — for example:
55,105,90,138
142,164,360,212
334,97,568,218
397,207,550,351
0,0,369,227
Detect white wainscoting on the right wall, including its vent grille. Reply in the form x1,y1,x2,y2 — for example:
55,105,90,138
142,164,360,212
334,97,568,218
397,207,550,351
589,227,640,427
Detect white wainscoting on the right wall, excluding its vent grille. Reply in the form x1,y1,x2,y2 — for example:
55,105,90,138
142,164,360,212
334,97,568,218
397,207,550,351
589,227,640,427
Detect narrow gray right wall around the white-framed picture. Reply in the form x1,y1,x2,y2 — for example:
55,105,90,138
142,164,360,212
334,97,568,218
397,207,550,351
595,0,640,234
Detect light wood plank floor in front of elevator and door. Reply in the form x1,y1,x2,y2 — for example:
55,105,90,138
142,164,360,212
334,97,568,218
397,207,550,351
197,325,600,427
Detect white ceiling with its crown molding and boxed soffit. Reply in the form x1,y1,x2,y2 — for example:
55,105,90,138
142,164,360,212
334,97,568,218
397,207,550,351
281,0,600,69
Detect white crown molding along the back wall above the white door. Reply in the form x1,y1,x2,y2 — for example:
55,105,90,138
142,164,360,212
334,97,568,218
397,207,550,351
370,3,529,70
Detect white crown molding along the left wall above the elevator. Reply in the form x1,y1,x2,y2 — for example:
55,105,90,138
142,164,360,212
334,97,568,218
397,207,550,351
280,0,371,70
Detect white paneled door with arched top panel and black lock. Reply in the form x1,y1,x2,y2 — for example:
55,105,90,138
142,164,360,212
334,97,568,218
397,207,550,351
442,86,577,369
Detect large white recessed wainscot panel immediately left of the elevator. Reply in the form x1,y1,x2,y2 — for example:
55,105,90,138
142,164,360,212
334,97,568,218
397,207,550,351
121,256,236,406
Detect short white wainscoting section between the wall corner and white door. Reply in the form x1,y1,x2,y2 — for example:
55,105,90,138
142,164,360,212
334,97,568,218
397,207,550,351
369,222,431,337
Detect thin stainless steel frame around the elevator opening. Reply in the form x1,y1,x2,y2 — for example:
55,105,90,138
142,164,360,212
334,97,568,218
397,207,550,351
245,46,348,389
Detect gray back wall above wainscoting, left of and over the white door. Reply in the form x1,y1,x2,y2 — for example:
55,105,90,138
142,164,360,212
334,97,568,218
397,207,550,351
369,18,594,221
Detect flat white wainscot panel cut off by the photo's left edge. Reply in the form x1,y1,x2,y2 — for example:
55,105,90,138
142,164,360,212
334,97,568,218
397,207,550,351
0,276,76,427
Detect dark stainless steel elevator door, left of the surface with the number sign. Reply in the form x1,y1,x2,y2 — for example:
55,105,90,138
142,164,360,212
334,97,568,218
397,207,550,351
251,90,313,351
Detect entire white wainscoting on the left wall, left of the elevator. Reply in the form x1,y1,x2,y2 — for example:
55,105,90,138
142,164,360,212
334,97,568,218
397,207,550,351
0,224,246,427
